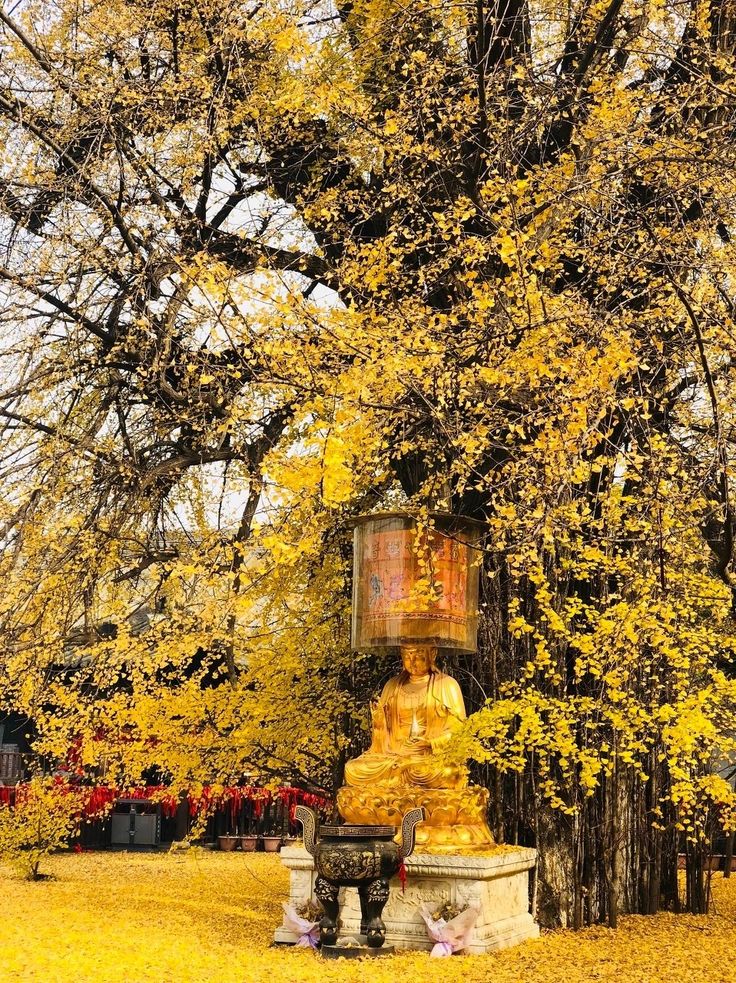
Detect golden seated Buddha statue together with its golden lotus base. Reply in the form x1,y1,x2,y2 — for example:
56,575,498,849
337,645,493,853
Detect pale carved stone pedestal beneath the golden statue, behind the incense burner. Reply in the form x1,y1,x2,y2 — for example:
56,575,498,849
274,847,539,954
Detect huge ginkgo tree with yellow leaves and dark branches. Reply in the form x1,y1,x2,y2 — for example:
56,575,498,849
0,0,736,925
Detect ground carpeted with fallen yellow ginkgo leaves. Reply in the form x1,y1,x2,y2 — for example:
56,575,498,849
0,851,736,983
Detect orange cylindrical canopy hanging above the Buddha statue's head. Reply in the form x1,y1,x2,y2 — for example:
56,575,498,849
353,512,484,652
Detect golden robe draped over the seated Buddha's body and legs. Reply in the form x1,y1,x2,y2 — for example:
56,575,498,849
345,670,467,788
